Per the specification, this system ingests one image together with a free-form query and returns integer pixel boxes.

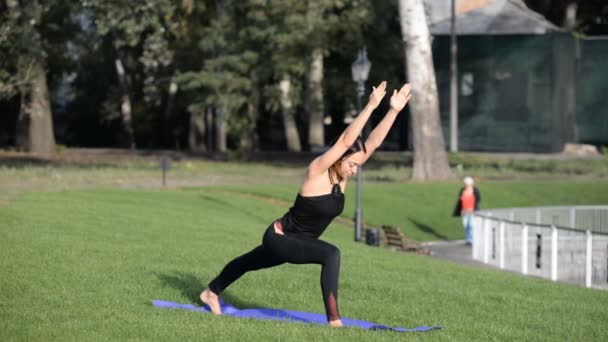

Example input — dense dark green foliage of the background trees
[0,0,607,148]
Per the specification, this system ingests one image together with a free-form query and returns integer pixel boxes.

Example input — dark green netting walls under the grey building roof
[433,34,608,152]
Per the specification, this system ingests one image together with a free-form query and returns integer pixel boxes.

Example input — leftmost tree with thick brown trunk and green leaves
[0,0,55,153]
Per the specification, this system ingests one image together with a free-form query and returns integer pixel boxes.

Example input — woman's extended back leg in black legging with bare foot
[200,245,285,315]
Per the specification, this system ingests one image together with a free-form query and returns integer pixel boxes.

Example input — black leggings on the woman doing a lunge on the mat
[209,224,340,321]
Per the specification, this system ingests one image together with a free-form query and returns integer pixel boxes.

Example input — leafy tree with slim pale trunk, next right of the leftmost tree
[82,0,183,148]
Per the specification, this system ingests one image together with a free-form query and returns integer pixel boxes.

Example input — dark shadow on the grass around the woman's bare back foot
[156,272,264,309]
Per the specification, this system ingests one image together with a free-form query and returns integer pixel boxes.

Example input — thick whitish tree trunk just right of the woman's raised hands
[399,0,452,180]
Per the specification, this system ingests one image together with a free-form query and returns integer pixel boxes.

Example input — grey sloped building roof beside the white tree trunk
[426,0,563,35]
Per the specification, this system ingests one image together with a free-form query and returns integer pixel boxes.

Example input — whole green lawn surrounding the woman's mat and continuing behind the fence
[0,187,608,341]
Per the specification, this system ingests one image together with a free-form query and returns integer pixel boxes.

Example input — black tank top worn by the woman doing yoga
[281,170,344,238]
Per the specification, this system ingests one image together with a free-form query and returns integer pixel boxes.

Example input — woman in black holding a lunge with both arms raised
[200,81,411,327]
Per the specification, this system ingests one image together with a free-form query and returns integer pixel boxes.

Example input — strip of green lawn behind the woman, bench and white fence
[221,180,608,241]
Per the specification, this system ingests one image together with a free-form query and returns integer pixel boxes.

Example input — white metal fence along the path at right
[473,206,608,289]
